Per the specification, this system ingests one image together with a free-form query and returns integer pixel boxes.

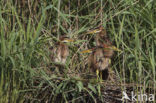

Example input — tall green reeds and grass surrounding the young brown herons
[0,0,156,103]
